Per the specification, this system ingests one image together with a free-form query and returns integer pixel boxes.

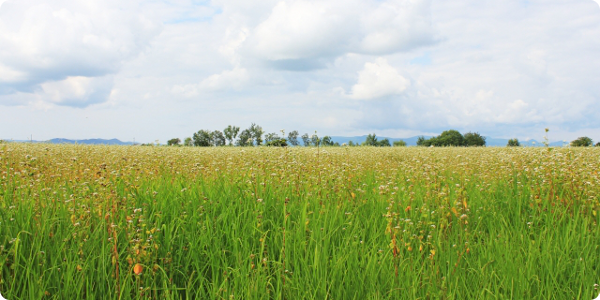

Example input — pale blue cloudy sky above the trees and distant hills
[0,0,600,143]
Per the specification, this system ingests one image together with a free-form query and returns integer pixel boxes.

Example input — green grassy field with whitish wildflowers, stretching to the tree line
[0,143,600,300]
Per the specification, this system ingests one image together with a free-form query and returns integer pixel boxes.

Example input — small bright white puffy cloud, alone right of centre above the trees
[350,57,410,99]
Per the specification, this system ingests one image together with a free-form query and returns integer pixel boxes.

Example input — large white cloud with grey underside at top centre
[241,0,436,71]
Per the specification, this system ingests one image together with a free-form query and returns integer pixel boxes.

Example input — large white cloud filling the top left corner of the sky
[0,0,160,105]
